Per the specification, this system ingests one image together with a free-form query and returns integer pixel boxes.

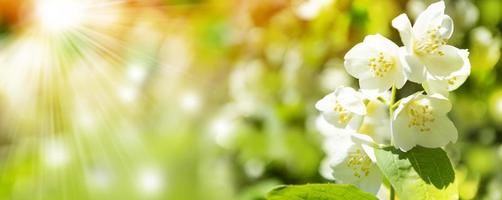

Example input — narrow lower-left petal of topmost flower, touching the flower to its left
[399,47,427,83]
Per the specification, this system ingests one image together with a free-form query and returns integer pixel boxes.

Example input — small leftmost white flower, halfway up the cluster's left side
[315,87,366,128]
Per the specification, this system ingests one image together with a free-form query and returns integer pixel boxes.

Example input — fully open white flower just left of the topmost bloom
[344,34,406,91]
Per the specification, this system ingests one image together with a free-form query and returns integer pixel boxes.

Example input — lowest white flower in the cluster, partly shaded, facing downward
[323,130,383,194]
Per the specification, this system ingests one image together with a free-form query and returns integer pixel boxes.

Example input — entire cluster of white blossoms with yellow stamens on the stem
[315,1,471,193]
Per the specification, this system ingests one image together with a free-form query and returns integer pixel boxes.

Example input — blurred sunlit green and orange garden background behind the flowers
[0,0,502,200]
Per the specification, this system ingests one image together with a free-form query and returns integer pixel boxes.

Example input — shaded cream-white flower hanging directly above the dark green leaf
[391,92,457,151]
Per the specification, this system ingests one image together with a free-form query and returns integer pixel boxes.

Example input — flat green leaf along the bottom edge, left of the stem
[267,184,377,200]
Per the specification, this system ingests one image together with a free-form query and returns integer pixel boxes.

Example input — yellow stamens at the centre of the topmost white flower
[413,26,448,56]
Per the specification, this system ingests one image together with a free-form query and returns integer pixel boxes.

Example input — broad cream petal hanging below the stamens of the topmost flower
[422,45,464,77]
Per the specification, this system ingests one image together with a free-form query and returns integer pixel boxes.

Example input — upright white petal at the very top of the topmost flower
[413,1,445,36]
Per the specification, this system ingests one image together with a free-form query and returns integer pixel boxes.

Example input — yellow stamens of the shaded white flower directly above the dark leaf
[407,102,434,132]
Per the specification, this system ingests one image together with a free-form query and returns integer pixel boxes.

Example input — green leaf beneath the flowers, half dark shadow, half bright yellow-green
[375,146,458,200]
